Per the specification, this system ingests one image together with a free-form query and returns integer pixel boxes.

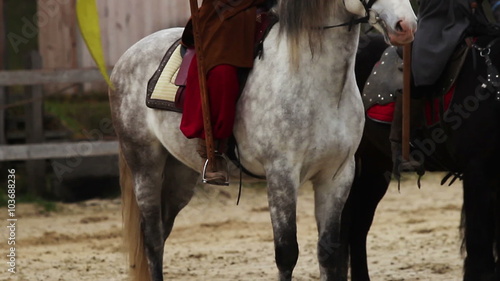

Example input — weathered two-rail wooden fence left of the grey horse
[0,55,118,194]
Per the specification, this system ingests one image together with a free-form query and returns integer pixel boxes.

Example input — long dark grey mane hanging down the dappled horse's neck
[277,0,338,62]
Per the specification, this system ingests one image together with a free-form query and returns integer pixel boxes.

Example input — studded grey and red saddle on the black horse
[362,40,470,126]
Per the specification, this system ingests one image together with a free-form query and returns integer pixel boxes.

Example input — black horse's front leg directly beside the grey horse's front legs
[344,153,391,281]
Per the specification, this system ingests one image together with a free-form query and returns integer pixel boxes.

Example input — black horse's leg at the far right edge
[463,161,497,281]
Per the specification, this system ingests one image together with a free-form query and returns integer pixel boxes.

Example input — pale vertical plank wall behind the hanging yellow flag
[37,0,190,71]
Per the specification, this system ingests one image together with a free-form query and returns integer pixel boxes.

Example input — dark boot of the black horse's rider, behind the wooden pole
[389,95,425,177]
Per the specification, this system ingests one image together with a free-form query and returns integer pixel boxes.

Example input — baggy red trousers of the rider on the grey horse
[180,56,240,139]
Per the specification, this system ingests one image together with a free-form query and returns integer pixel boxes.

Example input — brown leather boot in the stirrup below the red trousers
[196,139,229,185]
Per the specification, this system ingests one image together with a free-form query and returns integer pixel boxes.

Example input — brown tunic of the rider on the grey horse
[182,0,267,72]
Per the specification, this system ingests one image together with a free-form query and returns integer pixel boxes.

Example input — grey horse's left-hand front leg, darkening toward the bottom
[267,170,299,281]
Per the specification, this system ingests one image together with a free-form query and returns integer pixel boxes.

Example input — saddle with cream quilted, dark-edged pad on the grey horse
[146,11,278,113]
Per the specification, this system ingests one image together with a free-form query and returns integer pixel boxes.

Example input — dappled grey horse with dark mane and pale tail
[110,0,416,281]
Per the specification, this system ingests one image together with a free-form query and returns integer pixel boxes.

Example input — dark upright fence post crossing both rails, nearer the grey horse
[25,51,46,195]
